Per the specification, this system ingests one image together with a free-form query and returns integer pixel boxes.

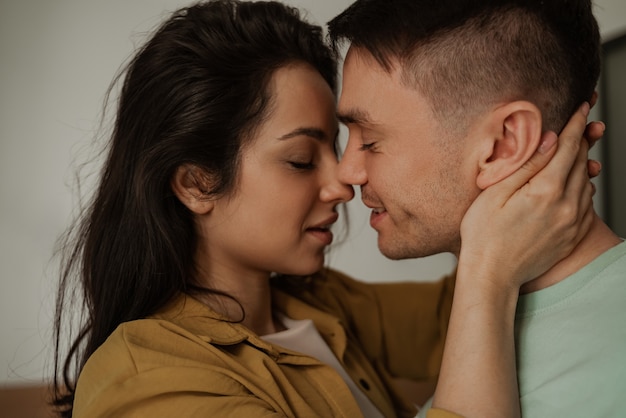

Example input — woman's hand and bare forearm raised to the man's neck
[433,104,604,417]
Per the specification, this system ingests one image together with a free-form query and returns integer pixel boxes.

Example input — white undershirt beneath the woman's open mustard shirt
[261,316,384,418]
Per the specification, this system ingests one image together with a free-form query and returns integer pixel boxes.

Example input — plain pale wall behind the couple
[0,0,626,385]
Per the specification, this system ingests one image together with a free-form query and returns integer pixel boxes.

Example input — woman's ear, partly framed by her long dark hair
[170,164,215,215]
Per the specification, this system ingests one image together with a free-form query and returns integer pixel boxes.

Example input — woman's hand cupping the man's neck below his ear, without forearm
[460,104,604,289]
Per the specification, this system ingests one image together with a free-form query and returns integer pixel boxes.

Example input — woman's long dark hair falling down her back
[53,0,336,417]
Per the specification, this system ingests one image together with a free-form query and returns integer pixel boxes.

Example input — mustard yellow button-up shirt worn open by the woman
[74,270,455,418]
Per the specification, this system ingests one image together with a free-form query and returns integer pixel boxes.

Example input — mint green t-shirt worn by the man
[515,242,626,418]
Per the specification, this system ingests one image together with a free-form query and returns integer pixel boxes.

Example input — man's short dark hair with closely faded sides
[328,0,600,132]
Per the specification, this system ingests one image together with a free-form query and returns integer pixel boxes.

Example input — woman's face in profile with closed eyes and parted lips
[199,64,354,277]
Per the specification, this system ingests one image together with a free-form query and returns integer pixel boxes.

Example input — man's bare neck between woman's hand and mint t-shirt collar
[520,215,621,294]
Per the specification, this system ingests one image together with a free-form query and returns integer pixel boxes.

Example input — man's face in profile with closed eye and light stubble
[338,47,479,259]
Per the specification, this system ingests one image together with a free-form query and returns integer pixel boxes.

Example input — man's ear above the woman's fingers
[476,101,542,190]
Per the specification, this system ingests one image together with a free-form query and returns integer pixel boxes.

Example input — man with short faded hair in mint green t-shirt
[329,0,626,417]
